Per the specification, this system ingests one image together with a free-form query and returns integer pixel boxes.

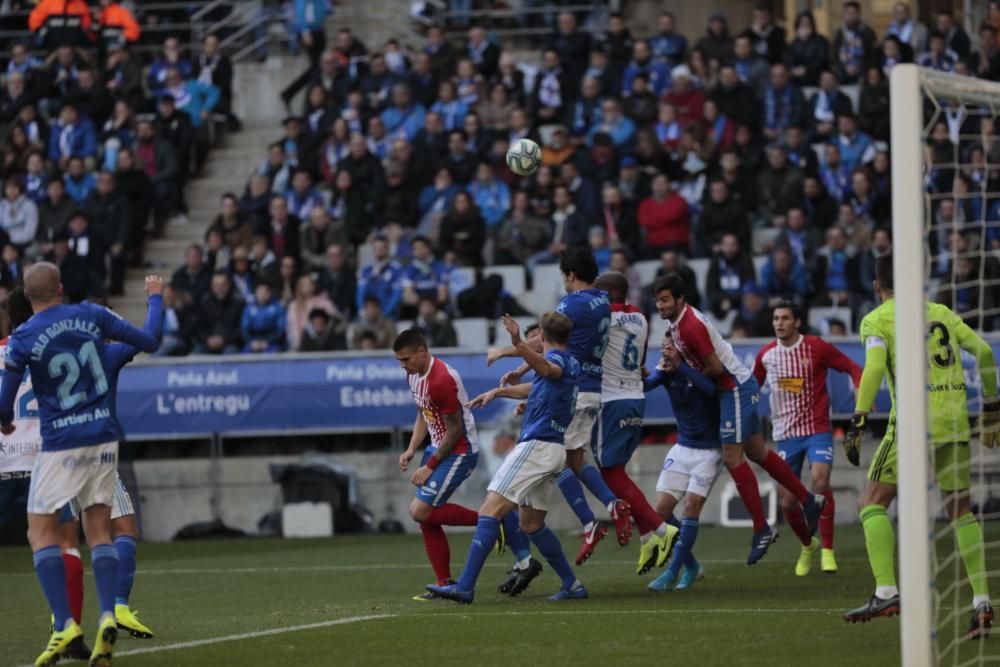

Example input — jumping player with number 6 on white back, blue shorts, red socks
[592,271,679,574]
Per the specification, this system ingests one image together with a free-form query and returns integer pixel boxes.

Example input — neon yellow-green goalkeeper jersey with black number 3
[857,299,996,444]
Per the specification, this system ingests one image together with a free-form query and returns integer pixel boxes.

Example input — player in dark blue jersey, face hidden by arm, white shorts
[643,336,722,591]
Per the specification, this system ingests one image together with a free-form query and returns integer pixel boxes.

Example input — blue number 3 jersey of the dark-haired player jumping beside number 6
[556,287,611,394]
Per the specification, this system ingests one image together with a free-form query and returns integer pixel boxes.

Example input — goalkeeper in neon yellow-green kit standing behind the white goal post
[844,256,1000,639]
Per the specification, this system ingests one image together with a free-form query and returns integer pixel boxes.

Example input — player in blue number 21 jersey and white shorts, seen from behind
[0,262,158,667]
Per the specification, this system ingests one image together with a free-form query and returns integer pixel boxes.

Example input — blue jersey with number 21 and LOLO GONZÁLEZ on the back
[0,296,160,451]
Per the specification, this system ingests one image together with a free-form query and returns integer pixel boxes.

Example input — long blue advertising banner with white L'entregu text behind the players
[118,341,1000,439]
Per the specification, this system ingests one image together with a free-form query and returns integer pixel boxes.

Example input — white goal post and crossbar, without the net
[889,65,1000,667]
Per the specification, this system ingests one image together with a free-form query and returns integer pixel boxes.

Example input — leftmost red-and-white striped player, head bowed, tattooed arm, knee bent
[392,329,479,600]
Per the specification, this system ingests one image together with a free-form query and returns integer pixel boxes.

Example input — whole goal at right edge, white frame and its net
[891,65,1000,666]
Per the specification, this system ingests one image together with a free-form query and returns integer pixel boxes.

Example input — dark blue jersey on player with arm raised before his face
[643,363,722,449]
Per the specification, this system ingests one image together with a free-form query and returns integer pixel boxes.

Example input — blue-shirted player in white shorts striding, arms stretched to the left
[427,313,587,604]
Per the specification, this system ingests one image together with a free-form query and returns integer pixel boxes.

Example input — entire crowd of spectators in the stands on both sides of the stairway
[0,0,1000,354]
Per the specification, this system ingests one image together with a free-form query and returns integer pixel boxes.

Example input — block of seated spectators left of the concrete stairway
[0,0,240,324]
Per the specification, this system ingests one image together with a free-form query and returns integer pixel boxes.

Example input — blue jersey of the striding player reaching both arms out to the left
[519,350,580,445]
